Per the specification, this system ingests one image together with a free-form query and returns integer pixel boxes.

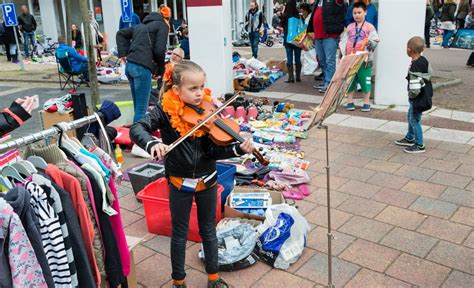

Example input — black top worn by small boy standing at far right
[406,56,433,112]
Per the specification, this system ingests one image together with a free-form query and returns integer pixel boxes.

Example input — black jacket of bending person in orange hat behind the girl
[116,13,169,75]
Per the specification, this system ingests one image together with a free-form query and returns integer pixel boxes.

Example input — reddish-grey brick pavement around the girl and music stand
[120,125,474,287]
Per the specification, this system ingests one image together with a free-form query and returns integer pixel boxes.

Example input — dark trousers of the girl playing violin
[169,185,219,280]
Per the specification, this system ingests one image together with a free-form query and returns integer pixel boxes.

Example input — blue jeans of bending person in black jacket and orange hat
[125,62,151,123]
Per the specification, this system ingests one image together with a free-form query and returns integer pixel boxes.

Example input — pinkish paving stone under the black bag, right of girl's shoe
[218,261,272,287]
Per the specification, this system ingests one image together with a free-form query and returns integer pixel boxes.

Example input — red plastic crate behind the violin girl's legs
[137,178,224,242]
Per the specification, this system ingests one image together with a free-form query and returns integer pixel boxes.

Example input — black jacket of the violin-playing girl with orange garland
[130,106,245,178]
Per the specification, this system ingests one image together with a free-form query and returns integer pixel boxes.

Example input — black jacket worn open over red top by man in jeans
[306,0,346,34]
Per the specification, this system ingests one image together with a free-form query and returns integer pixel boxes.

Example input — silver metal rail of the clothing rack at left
[0,113,98,153]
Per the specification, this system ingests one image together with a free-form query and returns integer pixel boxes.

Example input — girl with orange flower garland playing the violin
[130,60,253,288]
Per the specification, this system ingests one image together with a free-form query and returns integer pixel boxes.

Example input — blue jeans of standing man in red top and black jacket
[316,38,337,87]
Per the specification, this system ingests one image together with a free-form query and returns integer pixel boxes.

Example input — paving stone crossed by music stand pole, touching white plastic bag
[306,227,355,256]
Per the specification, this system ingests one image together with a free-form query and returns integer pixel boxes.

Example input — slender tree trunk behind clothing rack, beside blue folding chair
[79,0,100,110]
